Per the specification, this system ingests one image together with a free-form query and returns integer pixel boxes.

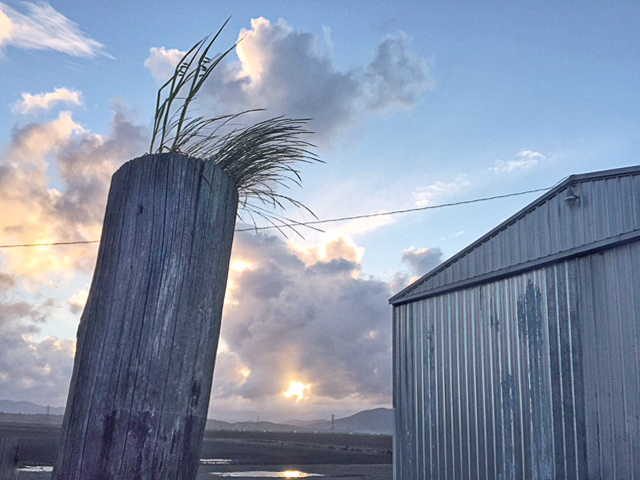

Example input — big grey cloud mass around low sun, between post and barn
[214,234,391,418]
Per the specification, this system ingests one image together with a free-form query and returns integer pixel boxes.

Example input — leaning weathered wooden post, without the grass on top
[52,153,238,480]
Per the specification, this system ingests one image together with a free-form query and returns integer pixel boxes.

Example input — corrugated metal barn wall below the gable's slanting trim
[394,240,640,480]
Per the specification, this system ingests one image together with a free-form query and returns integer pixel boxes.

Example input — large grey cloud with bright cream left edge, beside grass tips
[200,17,361,144]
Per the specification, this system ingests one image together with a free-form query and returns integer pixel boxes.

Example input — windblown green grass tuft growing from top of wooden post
[149,19,320,233]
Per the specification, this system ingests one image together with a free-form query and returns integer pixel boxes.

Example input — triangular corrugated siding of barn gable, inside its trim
[404,170,640,296]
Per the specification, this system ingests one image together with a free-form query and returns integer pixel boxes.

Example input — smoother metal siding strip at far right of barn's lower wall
[578,242,640,479]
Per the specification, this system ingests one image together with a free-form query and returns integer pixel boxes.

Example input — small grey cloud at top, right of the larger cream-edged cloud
[366,32,435,109]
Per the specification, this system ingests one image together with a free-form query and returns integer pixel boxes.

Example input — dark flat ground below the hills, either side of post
[0,424,392,480]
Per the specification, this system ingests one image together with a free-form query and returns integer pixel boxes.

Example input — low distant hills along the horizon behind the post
[0,400,393,435]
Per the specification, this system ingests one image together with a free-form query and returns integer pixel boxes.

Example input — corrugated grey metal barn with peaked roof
[390,167,640,480]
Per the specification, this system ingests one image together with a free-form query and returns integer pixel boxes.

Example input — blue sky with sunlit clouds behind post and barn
[0,0,640,421]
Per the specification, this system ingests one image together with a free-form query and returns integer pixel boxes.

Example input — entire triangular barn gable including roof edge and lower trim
[389,166,640,305]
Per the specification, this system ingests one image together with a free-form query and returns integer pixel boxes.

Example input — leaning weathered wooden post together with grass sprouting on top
[53,25,317,480]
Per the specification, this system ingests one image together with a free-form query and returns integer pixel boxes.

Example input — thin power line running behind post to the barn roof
[0,187,553,248]
